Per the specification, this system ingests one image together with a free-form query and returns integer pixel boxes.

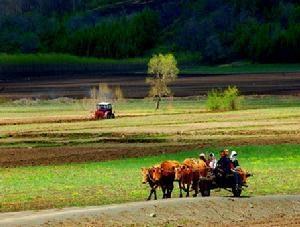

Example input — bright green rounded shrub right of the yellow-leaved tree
[206,86,242,111]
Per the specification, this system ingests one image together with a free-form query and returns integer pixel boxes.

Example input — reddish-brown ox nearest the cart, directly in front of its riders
[175,158,207,197]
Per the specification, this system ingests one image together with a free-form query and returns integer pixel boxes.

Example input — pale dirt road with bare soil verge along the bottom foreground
[0,195,300,227]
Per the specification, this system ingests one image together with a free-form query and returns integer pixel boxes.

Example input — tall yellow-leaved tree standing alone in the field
[146,54,179,109]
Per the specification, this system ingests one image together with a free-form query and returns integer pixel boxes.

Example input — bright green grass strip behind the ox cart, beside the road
[0,145,300,212]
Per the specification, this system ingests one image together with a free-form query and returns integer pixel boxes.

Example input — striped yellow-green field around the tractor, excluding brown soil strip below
[0,96,300,148]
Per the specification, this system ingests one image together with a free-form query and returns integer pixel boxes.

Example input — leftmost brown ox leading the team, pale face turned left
[142,166,161,200]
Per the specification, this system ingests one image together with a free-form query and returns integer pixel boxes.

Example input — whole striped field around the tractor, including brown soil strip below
[0,96,300,166]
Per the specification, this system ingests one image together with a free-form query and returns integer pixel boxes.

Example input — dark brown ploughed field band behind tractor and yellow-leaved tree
[0,73,300,98]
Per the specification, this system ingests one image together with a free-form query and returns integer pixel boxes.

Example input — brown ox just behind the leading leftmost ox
[160,160,180,198]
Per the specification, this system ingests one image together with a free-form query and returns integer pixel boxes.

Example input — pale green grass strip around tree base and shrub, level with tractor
[0,95,300,118]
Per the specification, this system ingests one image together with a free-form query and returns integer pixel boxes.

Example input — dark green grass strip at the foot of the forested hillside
[0,54,300,74]
